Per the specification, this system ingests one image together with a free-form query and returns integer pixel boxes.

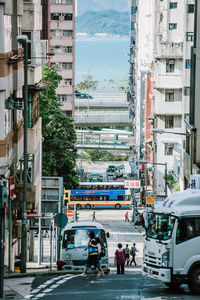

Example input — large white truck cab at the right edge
[142,189,200,294]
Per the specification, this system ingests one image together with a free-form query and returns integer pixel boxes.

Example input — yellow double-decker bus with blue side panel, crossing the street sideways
[63,182,133,209]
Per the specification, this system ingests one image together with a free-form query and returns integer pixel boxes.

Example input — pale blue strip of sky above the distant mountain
[77,0,130,16]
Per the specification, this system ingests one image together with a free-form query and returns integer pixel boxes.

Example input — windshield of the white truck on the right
[146,214,175,240]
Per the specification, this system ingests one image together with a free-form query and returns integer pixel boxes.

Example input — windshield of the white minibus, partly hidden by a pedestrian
[63,229,107,249]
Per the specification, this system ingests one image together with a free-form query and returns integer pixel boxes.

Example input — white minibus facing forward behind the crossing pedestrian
[62,221,109,273]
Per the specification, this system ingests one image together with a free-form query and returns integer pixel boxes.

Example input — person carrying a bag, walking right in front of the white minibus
[83,231,103,276]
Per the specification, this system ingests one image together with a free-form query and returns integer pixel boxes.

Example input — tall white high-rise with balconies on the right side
[132,0,194,194]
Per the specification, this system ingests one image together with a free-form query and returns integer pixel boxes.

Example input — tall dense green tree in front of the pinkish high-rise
[40,66,78,188]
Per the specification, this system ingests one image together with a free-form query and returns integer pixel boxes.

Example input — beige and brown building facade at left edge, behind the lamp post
[0,0,47,270]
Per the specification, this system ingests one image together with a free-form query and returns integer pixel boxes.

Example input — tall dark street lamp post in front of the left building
[17,35,28,273]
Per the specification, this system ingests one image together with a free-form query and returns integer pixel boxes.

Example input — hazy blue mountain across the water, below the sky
[76,10,130,35]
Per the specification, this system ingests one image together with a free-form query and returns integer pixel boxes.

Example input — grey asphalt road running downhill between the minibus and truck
[25,210,200,300]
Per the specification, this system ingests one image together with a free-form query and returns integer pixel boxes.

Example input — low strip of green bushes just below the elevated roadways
[81,149,128,161]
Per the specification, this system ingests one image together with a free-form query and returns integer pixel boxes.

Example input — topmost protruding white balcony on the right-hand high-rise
[155,43,183,59]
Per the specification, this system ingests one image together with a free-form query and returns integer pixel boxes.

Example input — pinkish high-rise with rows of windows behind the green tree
[49,0,75,117]
